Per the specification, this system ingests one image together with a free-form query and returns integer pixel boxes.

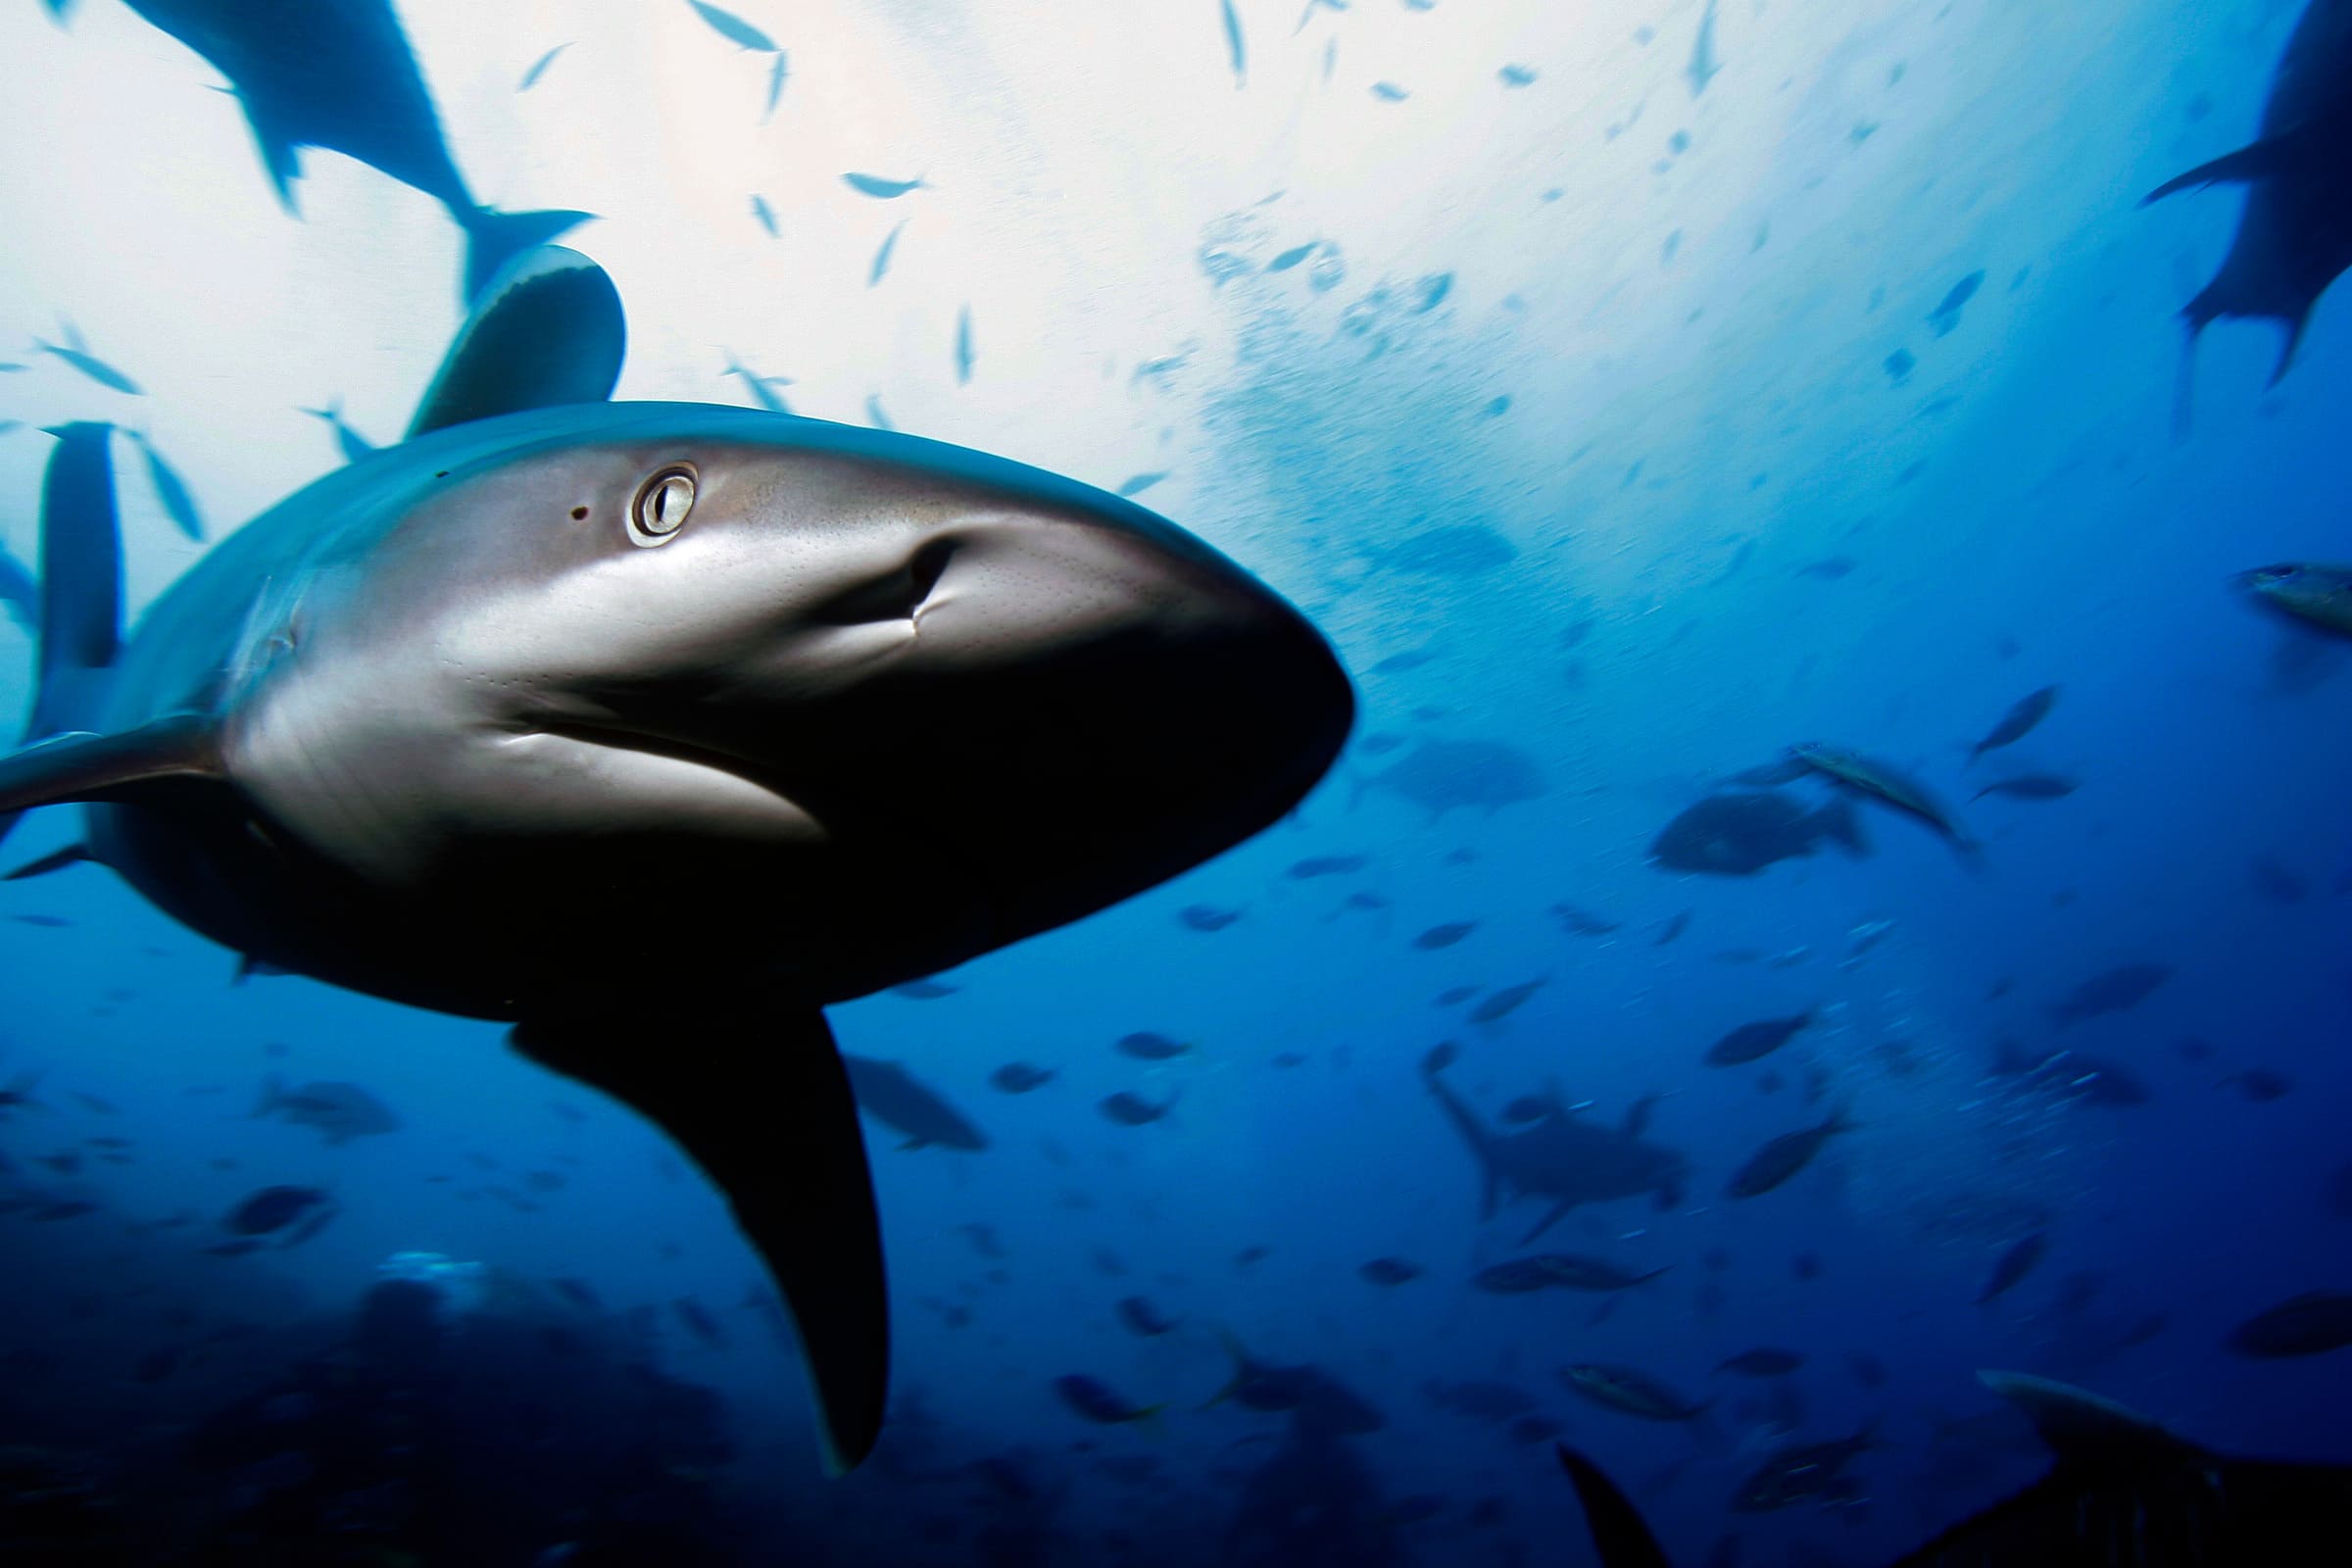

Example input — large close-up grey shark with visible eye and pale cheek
[0,247,1352,1464]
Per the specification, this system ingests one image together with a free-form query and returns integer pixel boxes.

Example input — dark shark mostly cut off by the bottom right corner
[1559,1373,2352,1568]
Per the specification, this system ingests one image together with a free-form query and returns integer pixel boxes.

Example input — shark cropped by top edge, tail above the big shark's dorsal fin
[49,0,588,299]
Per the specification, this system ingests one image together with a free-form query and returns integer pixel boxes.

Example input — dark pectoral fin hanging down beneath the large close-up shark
[513,999,889,1472]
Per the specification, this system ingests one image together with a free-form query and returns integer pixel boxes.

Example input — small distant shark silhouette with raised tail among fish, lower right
[1423,1069,1691,1246]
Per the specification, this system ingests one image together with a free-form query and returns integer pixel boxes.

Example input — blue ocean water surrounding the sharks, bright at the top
[0,0,2352,1568]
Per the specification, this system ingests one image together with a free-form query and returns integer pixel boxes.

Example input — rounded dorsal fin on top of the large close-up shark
[410,244,628,437]
